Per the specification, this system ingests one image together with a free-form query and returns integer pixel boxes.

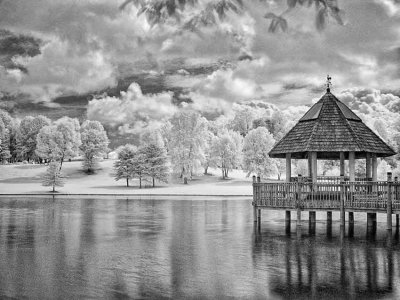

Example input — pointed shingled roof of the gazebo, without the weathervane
[269,89,396,159]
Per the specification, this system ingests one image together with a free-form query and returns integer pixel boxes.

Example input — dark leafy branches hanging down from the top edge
[120,0,344,32]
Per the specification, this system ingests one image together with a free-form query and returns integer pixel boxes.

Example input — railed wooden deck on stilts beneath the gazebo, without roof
[253,173,400,230]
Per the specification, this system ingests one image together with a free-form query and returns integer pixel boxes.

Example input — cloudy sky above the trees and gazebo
[0,0,400,138]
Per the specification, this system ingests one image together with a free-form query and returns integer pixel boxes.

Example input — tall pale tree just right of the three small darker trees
[167,110,206,183]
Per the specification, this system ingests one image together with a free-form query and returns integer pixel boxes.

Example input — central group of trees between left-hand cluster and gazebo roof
[113,106,304,186]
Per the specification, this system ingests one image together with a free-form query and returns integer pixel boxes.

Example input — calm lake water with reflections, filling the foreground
[0,198,400,299]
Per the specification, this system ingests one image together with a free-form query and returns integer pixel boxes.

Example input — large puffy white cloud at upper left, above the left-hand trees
[16,37,116,101]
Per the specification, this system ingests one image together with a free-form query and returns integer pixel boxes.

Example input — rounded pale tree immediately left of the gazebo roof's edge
[243,127,276,177]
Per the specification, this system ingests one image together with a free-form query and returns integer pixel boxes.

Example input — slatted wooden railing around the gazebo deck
[253,181,400,211]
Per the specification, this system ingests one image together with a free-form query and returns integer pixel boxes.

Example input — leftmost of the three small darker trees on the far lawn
[114,144,137,187]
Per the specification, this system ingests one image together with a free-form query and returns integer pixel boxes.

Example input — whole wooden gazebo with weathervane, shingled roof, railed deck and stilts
[253,77,400,230]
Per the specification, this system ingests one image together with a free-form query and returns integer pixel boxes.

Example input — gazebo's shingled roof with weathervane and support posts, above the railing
[269,77,396,182]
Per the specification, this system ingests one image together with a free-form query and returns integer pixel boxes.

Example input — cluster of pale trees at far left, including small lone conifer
[0,110,109,191]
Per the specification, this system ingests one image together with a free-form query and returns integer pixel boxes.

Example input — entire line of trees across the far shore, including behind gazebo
[0,105,400,191]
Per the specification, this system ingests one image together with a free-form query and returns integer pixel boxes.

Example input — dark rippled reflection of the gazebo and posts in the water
[253,228,400,299]
